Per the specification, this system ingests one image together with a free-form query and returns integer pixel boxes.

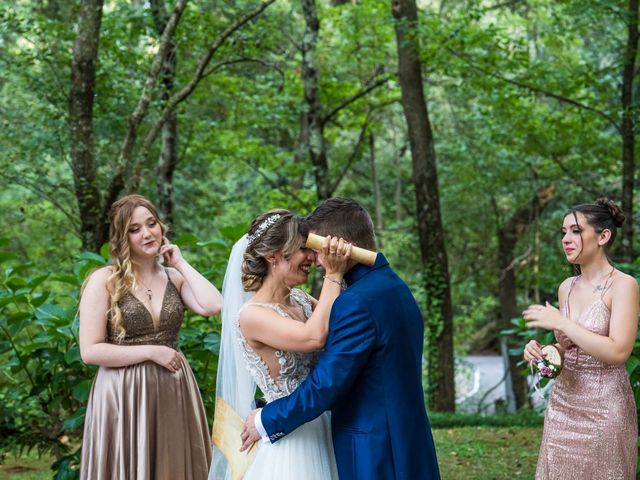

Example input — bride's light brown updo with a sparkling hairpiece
[242,208,304,292]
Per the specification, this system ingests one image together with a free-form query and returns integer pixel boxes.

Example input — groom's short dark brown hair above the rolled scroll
[301,197,376,250]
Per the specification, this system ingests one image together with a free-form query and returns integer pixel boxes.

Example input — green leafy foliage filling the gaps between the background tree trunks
[0,0,640,462]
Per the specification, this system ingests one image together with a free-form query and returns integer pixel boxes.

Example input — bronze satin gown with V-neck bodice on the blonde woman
[80,273,211,480]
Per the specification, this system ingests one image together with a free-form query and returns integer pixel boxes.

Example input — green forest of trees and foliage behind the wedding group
[0,0,640,478]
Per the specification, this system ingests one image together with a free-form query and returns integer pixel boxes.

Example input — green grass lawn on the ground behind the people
[0,427,542,480]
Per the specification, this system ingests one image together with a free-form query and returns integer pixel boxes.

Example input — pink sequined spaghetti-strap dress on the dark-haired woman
[536,277,638,480]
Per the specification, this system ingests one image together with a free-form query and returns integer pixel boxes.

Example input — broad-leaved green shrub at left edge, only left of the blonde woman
[0,241,105,478]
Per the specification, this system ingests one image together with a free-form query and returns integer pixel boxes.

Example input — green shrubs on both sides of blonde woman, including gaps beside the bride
[0,228,232,479]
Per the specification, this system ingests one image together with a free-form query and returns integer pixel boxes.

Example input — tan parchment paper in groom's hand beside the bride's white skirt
[211,397,258,480]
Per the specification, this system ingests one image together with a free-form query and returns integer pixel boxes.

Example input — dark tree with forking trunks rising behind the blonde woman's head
[70,0,275,250]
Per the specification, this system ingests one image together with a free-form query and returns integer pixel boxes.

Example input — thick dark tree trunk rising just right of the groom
[392,0,455,412]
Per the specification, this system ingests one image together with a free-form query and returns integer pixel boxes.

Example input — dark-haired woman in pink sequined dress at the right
[523,198,639,480]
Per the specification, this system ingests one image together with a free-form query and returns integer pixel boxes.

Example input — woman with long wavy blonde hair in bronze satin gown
[80,195,222,480]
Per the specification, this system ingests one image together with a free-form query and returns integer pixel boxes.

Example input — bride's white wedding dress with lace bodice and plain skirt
[237,289,338,480]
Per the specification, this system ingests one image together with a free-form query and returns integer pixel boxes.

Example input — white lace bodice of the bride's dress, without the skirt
[236,289,319,402]
